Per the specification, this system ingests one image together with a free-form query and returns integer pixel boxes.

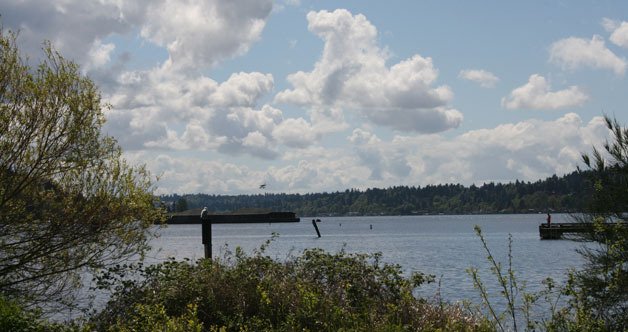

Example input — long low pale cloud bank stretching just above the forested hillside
[140,113,609,194]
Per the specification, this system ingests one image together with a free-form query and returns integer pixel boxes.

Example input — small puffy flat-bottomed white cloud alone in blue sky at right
[502,74,589,110]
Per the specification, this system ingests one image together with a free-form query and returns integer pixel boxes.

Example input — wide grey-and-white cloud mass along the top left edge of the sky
[2,0,273,69]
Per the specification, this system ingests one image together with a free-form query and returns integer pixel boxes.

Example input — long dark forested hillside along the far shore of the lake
[161,171,592,216]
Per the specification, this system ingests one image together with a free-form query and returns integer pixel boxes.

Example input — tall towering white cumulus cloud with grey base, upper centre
[275,9,462,132]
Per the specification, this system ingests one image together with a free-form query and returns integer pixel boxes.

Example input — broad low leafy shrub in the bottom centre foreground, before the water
[90,243,490,331]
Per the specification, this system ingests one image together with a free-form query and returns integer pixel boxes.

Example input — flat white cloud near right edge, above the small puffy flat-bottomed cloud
[550,36,626,75]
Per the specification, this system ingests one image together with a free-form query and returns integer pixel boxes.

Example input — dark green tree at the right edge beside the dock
[570,116,628,331]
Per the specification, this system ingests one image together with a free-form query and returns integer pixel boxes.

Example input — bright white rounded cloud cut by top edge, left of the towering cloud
[141,0,272,69]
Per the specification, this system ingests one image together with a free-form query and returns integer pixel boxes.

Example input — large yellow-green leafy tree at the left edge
[0,29,162,303]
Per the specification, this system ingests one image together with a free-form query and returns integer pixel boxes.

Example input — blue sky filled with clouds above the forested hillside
[0,0,628,195]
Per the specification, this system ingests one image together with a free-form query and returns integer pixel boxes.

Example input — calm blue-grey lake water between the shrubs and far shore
[150,214,583,303]
